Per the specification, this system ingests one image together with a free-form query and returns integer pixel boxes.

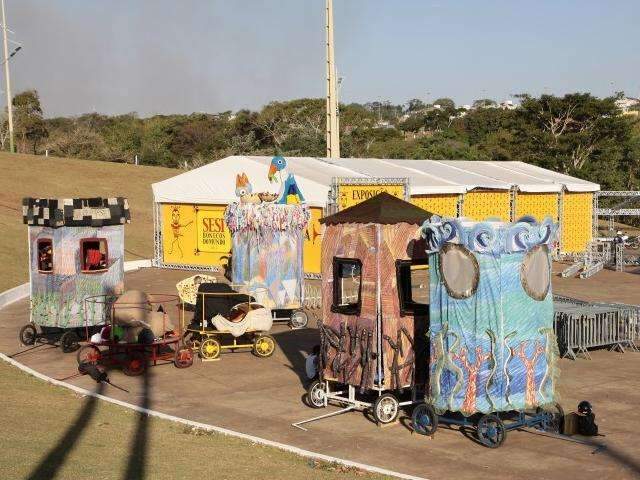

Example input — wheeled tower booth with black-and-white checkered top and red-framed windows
[20,197,131,352]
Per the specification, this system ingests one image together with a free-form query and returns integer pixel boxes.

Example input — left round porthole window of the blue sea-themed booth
[440,243,480,299]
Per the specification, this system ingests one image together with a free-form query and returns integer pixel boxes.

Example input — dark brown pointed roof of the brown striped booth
[320,192,431,225]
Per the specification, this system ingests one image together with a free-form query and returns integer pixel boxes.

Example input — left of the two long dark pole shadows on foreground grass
[27,383,105,480]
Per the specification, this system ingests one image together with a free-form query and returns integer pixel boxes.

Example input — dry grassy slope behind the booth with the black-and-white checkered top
[0,153,175,291]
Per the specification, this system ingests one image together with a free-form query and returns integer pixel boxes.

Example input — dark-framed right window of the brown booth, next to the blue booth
[396,259,429,315]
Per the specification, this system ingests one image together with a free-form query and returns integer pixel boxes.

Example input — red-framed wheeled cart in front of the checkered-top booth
[77,294,193,376]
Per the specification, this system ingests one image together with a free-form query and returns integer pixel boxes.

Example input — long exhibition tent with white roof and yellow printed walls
[153,156,600,276]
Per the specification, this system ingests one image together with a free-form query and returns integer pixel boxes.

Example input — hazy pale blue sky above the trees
[3,0,640,116]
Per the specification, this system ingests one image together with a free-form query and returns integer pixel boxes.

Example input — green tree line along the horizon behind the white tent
[6,90,640,190]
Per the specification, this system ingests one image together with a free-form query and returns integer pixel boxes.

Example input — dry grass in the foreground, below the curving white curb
[0,361,385,480]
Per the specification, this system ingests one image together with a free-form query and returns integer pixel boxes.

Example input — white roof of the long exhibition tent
[153,155,600,207]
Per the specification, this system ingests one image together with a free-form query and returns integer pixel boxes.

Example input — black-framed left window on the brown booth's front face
[331,257,362,315]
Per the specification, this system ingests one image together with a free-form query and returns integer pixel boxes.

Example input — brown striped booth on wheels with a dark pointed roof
[294,193,431,428]
